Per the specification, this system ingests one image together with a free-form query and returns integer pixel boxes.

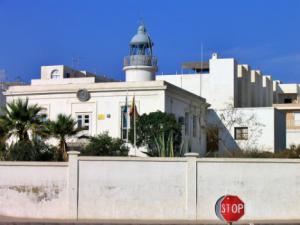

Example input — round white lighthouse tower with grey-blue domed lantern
[123,25,157,81]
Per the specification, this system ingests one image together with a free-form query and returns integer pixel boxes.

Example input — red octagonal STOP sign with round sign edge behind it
[215,195,245,222]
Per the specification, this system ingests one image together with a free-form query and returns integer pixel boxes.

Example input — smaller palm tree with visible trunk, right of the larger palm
[48,114,82,161]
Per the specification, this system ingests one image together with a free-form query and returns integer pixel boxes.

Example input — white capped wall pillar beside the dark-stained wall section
[68,151,80,220]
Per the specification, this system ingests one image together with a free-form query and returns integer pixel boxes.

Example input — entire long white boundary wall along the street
[0,152,300,221]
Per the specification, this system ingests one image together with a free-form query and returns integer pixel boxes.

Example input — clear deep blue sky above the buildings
[0,0,300,83]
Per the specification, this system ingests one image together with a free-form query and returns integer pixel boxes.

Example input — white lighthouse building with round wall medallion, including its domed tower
[5,26,208,155]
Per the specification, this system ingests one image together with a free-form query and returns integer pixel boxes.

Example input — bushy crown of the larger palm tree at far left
[0,99,46,141]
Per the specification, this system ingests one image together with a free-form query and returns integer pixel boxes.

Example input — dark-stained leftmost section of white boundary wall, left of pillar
[0,162,69,219]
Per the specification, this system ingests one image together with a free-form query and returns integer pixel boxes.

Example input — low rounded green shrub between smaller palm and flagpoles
[81,133,129,156]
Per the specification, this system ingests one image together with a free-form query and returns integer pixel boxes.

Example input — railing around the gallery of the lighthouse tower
[124,55,157,67]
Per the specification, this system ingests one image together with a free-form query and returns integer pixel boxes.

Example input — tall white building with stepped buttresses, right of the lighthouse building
[156,54,286,152]
